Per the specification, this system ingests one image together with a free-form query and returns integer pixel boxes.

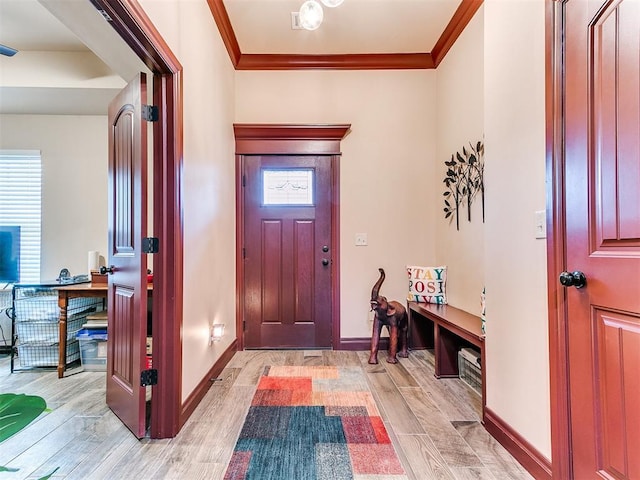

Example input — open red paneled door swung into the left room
[107,73,147,438]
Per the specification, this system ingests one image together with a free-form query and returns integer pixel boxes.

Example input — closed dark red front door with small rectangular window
[243,155,332,348]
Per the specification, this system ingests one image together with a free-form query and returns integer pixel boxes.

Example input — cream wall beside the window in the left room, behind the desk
[0,115,108,281]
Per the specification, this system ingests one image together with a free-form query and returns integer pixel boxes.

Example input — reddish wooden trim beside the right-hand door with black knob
[545,0,573,479]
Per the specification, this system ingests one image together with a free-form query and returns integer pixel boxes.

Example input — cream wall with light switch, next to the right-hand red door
[484,0,551,458]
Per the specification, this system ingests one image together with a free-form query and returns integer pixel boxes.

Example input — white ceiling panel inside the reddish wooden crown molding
[224,0,460,54]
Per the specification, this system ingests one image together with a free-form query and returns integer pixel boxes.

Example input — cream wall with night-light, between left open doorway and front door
[141,0,236,401]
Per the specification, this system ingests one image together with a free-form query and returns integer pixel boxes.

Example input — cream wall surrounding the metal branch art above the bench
[433,7,485,315]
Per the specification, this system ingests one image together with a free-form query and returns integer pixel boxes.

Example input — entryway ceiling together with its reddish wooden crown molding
[207,0,482,70]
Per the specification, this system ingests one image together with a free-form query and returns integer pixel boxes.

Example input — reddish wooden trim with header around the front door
[233,123,351,350]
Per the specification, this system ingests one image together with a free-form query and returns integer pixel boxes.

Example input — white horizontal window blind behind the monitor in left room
[0,150,42,287]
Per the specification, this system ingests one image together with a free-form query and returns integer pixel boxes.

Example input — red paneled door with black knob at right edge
[564,0,640,479]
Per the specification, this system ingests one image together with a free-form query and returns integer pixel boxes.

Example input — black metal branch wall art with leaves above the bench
[443,142,484,230]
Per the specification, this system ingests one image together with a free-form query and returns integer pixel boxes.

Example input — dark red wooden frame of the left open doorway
[90,0,186,438]
